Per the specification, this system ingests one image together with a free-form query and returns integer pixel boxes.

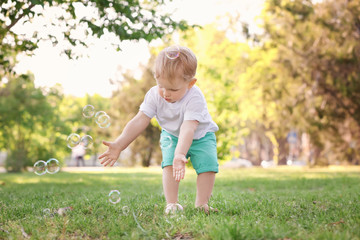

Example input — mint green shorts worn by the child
[160,130,219,175]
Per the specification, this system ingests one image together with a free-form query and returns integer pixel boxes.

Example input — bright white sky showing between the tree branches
[14,0,264,97]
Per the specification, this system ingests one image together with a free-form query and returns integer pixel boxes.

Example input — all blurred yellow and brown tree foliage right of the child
[167,0,360,164]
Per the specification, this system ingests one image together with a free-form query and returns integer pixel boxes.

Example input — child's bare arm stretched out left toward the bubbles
[99,111,151,166]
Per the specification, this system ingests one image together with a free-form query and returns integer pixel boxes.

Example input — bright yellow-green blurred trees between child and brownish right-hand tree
[184,24,286,165]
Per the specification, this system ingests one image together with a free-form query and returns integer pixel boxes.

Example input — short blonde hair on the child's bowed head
[154,46,197,82]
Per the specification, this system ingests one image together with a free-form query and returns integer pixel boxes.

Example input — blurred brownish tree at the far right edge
[253,0,360,164]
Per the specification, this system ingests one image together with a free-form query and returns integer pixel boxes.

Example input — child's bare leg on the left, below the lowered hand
[163,166,179,204]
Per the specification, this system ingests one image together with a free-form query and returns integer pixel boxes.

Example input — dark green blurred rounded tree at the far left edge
[0,74,66,172]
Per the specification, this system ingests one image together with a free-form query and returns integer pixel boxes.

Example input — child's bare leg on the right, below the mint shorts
[195,172,215,207]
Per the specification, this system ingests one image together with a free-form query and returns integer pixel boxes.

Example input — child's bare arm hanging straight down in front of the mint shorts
[173,120,199,182]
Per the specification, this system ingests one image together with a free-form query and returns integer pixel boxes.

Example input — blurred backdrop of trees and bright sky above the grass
[0,0,360,172]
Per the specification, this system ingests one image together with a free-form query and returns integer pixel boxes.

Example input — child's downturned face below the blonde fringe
[156,78,196,103]
